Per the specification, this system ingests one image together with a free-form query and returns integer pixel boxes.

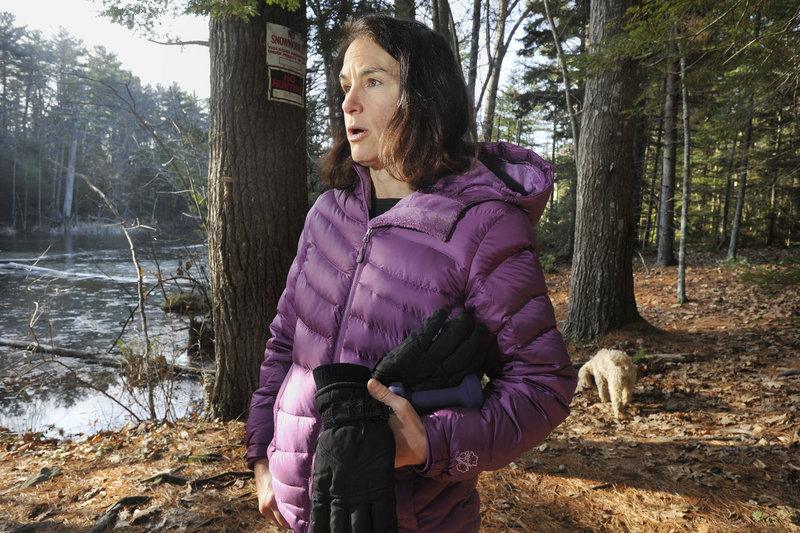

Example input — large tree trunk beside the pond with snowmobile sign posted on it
[207,2,308,419]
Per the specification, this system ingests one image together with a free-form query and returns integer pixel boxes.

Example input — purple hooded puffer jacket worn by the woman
[247,139,576,533]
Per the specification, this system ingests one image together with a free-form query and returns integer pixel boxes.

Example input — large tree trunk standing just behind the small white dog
[564,0,639,340]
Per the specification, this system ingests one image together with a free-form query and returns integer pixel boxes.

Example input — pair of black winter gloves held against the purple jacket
[311,309,484,533]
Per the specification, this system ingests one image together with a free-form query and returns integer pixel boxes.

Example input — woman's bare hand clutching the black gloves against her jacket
[367,379,428,468]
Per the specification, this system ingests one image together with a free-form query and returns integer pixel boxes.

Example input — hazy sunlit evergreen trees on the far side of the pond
[0,13,208,230]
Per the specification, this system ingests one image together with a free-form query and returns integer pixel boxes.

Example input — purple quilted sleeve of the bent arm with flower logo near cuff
[419,203,576,480]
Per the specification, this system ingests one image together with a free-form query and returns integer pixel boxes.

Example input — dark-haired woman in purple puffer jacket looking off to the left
[247,16,576,532]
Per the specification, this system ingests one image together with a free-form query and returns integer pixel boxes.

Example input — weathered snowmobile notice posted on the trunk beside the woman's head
[267,22,306,107]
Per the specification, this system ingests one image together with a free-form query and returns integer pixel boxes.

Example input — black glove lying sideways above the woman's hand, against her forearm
[372,309,486,392]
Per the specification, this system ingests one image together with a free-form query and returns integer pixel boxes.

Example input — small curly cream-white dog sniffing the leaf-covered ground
[578,348,636,418]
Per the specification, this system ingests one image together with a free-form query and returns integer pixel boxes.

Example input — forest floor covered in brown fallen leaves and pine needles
[0,250,800,533]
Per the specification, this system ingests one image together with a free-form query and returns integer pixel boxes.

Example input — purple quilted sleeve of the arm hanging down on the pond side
[247,218,308,468]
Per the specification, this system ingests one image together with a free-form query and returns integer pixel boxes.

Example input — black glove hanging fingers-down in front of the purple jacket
[311,363,397,533]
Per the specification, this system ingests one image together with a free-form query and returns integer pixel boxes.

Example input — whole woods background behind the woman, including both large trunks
[0,0,800,418]
